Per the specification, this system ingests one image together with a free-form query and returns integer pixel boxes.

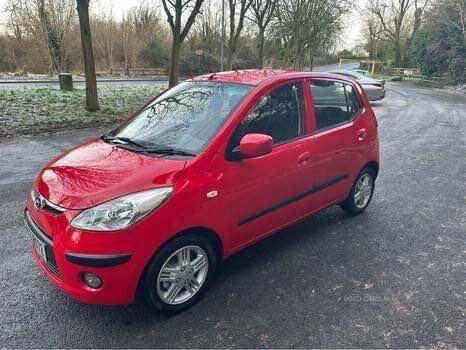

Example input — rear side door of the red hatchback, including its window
[308,79,366,208]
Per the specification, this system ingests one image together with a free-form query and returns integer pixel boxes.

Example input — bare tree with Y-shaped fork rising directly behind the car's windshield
[162,0,204,87]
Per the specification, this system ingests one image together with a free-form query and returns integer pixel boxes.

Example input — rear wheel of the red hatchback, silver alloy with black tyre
[340,168,375,215]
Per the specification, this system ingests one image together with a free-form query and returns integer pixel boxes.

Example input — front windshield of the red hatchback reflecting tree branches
[111,82,252,154]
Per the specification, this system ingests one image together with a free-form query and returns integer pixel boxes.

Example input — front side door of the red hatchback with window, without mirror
[223,81,312,249]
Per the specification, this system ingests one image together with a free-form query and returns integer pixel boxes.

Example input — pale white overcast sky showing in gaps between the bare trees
[0,0,367,48]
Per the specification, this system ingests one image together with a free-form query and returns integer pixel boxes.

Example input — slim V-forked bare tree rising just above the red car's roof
[227,0,251,70]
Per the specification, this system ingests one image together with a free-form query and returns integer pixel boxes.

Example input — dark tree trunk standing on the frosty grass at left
[76,0,99,111]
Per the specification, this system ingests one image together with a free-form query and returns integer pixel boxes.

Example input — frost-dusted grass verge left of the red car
[0,85,162,138]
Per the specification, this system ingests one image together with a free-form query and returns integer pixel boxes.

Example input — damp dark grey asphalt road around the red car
[0,84,466,348]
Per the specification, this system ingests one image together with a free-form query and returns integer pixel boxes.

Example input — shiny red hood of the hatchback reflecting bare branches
[35,139,186,209]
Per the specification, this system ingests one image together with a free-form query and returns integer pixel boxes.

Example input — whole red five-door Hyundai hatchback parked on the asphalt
[25,70,379,311]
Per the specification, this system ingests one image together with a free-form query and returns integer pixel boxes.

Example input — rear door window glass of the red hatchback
[311,80,361,130]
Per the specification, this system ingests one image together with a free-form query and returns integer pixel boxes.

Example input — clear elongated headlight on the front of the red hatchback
[71,187,173,231]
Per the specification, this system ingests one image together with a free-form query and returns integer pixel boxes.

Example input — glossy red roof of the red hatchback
[192,69,354,86]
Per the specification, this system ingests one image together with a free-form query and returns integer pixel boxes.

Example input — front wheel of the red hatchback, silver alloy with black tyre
[143,234,218,313]
